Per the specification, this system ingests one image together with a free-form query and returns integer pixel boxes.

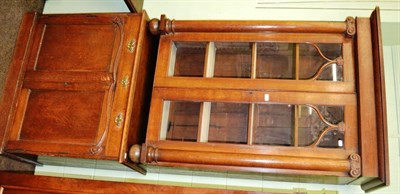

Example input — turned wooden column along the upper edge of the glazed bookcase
[149,15,356,37]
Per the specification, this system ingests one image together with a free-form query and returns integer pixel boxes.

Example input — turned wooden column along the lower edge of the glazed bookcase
[141,144,361,177]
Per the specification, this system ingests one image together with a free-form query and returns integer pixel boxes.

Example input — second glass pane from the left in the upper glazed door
[214,42,251,78]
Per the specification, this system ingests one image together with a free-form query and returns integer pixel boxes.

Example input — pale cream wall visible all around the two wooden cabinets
[36,0,400,194]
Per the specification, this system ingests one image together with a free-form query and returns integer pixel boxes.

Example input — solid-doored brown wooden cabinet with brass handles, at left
[0,12,156,171]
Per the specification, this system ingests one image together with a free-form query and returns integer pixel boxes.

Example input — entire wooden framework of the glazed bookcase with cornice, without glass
[133,8,388,190]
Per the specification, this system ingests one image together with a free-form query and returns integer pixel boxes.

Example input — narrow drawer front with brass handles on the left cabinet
[105,14,142,158]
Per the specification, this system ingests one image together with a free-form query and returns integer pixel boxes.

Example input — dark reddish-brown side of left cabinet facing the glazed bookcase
[119,12,158,162]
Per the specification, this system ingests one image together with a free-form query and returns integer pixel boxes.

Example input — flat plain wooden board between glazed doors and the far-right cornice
[356,18,378,177]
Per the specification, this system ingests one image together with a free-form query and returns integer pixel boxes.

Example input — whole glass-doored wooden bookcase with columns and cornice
[131,7,388,190]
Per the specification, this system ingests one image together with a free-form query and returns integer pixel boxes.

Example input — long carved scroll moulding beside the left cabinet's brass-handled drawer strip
[89,17,124,155]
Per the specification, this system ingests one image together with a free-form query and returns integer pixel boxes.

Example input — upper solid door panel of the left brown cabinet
[28,14,126,72]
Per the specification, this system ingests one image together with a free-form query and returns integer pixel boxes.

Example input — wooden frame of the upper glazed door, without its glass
[154,33,355,93]
